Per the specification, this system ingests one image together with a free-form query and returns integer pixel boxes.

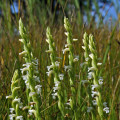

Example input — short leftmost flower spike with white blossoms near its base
[6,70,23,120]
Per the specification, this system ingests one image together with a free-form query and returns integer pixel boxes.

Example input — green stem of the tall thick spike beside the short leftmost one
[19,19,41,120]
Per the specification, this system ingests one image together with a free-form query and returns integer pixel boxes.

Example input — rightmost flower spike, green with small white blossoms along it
[88,34,109,120]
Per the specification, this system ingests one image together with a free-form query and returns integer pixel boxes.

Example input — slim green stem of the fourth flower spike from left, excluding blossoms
[64,18,78,120]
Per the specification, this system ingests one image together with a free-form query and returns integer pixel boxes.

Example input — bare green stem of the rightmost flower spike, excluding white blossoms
[89,35,103,120]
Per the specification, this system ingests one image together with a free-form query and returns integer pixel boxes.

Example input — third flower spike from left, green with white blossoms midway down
[46,27,65,119]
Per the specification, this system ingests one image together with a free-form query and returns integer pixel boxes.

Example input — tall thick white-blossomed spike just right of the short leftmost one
[19,19,42,120]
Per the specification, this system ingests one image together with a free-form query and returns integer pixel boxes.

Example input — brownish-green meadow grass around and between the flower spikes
[0,0,120,120]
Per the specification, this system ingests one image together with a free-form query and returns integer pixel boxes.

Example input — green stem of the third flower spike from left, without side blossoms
[46,28,65,119]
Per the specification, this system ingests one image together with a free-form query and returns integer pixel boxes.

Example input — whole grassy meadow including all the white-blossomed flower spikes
[0,0,120,120]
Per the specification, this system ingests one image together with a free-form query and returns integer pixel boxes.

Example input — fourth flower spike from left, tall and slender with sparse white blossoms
[63,18,79,119]
